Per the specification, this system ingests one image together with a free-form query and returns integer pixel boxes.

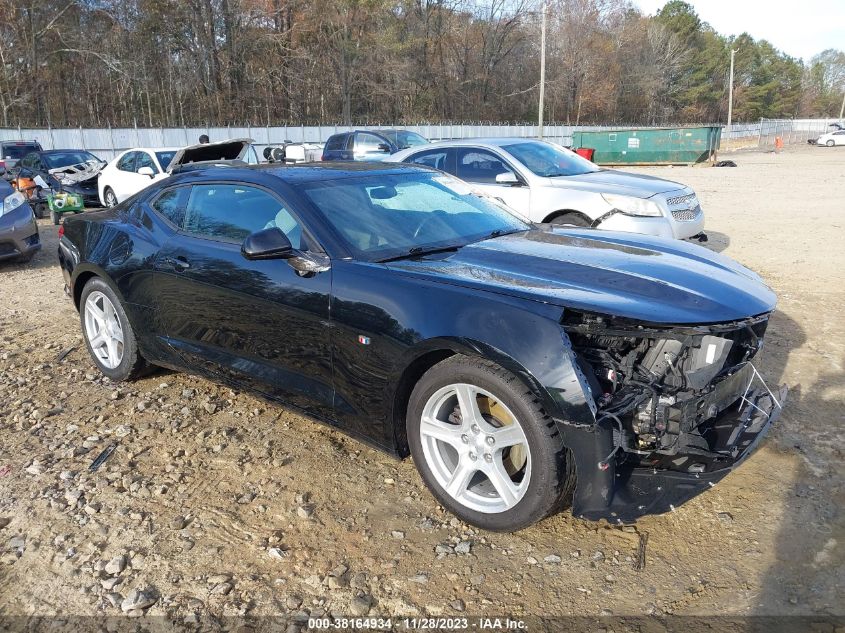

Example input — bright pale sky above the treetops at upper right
[633,0,845,61]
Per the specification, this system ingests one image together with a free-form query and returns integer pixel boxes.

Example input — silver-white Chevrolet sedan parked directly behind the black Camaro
[385,138,707,241]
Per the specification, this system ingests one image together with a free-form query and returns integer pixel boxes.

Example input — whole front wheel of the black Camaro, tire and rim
[406,355,575,532]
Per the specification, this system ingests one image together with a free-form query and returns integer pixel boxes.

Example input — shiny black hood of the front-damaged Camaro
[387,228,776,324]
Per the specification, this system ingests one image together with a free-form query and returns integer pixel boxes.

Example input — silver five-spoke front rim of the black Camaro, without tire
[420,383,531,513]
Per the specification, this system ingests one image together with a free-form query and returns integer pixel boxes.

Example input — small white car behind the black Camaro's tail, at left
[97,147,179,207]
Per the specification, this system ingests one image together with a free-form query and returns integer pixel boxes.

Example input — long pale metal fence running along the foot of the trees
[0,119,836,160]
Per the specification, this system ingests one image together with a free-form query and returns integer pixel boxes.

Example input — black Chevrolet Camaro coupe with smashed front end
[59,163,786,530]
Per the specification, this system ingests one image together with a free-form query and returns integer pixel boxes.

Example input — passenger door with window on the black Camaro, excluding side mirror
[150,182,334,417]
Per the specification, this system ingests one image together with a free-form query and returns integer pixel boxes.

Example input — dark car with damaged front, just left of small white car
[17,149,106,210]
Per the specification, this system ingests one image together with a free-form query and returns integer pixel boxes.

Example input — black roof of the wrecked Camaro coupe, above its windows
[169,162,435,183]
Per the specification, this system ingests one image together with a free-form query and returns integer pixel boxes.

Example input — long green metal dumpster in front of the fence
[572,126,722,165]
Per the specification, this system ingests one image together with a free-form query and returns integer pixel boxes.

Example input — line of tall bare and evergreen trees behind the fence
[0,0,845,127]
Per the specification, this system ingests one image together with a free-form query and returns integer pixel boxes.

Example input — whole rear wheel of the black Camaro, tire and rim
[79,277,146,382]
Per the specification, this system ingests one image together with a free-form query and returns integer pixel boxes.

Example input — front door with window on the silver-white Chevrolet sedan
[454,147,531,217]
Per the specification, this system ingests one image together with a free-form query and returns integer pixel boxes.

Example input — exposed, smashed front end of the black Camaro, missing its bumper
[561,311,787,523]
